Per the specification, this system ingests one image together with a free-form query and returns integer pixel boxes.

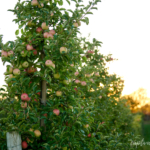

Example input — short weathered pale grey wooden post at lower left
[6,131,22,150]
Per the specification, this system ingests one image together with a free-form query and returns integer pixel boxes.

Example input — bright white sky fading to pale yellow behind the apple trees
[0,0,150,97]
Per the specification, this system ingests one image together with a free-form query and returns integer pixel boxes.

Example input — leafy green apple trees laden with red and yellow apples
[0,0,142,150]
